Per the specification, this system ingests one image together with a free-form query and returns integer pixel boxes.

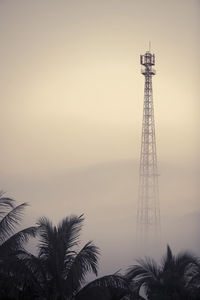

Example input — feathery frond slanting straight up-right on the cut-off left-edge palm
[0,203,28,242]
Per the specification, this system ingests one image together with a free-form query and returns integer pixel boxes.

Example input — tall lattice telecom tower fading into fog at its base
[137,51,160,246]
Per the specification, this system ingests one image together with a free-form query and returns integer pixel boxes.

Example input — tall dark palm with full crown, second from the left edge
[20,215,99,300]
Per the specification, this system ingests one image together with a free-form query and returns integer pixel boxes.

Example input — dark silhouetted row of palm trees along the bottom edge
[0,193,200,300]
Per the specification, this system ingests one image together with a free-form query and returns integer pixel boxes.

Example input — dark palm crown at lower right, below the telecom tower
[126,246,197,300]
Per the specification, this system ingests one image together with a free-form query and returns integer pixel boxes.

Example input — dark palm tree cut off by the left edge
[0,192,37,298]
